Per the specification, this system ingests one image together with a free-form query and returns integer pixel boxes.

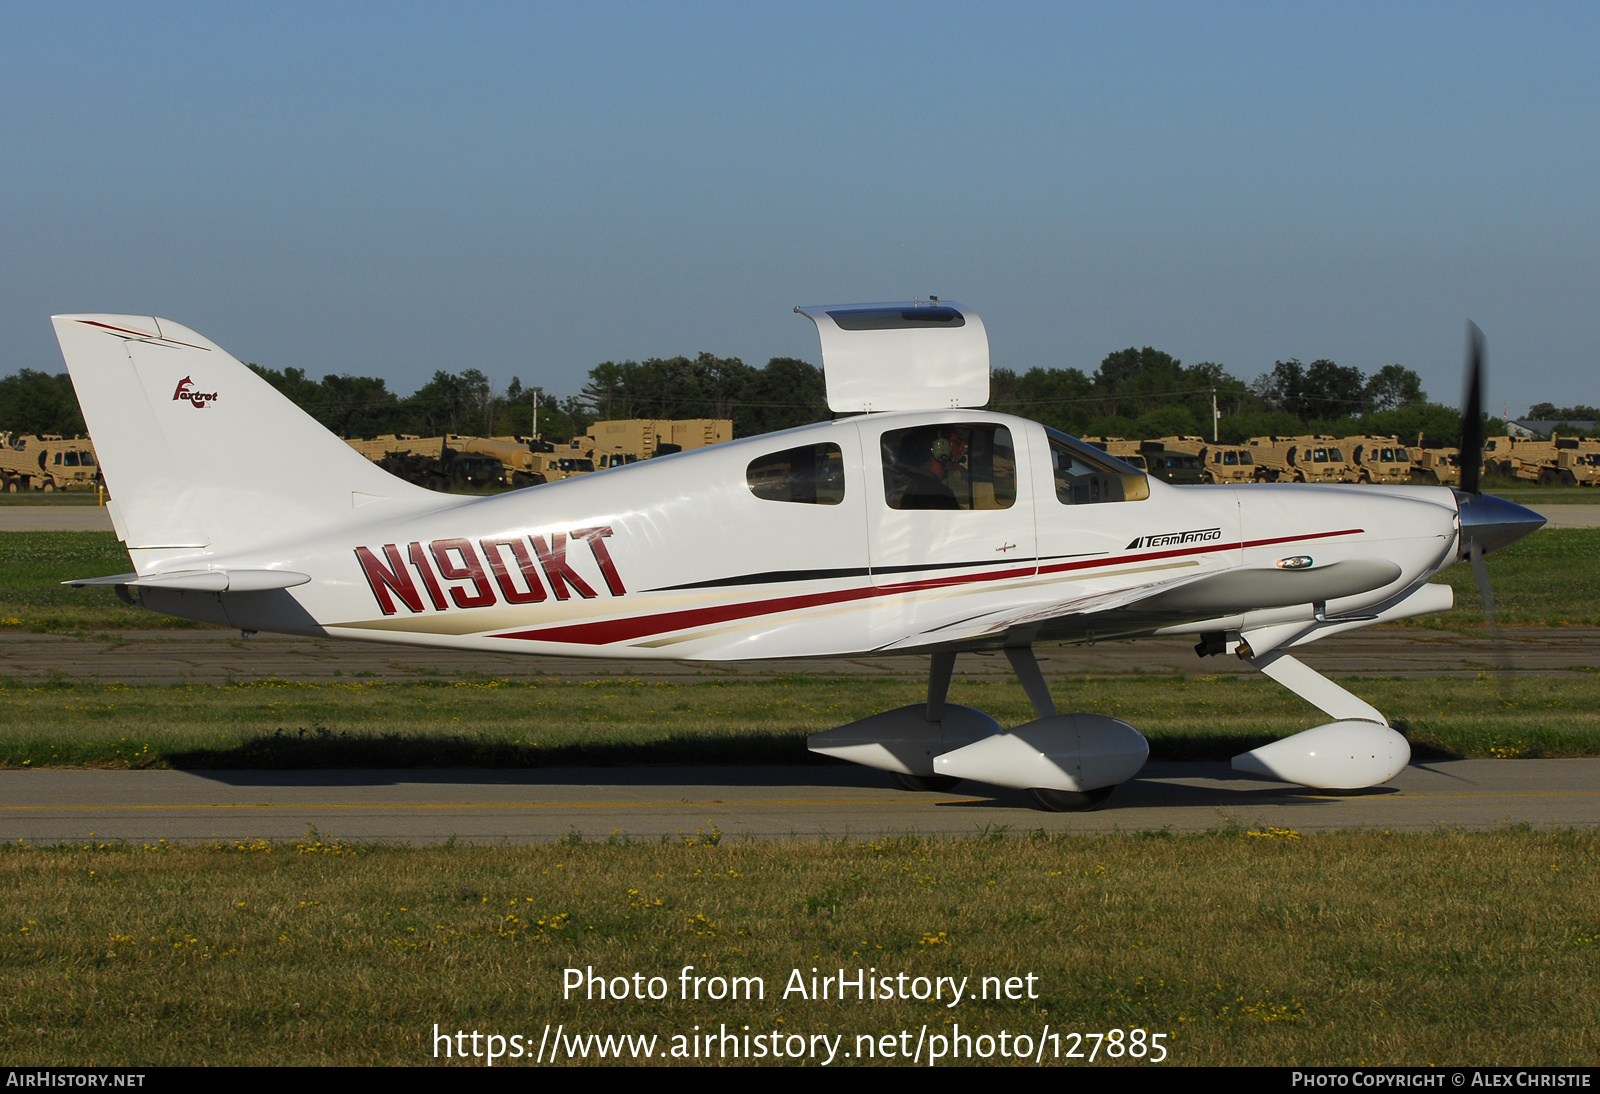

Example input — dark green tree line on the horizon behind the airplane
[0,345,1516,445]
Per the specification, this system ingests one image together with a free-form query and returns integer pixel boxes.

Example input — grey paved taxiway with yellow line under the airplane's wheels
[0,760,1600,844]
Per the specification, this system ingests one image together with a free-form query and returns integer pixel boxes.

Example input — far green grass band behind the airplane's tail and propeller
[0,527,1600,633]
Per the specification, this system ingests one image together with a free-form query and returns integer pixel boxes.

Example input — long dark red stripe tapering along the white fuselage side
[494,528,1363,646]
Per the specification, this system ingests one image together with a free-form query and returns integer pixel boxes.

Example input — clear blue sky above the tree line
[0,3,1600,414]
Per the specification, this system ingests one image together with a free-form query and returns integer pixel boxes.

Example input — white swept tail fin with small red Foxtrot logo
[53,315,438,552]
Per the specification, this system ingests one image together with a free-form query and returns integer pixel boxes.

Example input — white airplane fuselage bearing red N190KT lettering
[133,409,1458,661]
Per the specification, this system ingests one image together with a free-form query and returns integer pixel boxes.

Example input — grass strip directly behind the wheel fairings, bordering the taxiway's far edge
[0,673,1600,768]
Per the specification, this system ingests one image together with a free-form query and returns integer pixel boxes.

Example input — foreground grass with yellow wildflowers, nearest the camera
[0,828,1600,1067]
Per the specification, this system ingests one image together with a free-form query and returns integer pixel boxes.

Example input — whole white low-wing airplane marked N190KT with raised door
[54,301,1544,809]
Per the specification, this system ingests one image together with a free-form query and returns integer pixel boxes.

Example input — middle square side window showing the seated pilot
[882,422,1016,510]
